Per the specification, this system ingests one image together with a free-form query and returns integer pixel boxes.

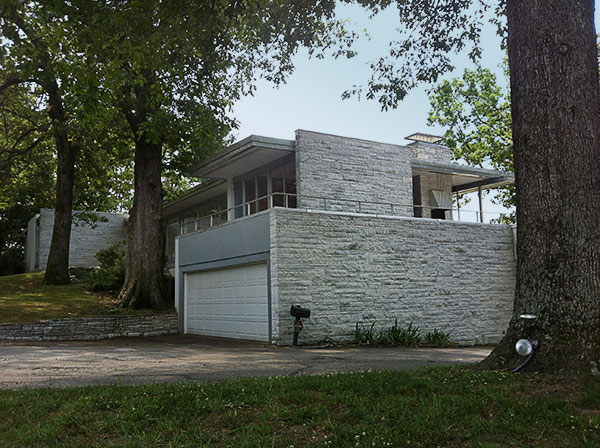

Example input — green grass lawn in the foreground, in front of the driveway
[0,367,600,448]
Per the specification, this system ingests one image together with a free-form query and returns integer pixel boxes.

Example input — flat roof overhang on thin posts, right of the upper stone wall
[411,159,515,193]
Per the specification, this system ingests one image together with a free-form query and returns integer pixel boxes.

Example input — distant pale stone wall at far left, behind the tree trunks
[27,208,128,271]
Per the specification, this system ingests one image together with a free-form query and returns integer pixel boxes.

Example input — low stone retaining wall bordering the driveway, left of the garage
[0,312,177,341]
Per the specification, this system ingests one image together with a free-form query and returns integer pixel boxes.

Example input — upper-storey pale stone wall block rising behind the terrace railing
[296,130,413,216]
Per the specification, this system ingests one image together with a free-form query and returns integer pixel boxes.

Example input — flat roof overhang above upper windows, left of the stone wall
[190,135,296,179]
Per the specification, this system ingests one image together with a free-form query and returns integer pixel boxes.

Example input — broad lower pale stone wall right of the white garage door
[271,209,516,345]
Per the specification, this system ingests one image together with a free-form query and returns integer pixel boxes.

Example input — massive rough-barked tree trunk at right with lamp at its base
[482,0,600,374]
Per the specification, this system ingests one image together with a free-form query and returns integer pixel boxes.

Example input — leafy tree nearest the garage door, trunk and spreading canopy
[57,0,354,308]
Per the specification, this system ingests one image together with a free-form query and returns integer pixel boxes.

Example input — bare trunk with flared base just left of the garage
[119,138,166,309]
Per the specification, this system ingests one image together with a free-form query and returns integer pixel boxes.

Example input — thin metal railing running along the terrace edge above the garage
[180,193,510,235]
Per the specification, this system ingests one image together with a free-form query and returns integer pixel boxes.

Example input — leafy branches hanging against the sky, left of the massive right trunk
[343,0,504,110]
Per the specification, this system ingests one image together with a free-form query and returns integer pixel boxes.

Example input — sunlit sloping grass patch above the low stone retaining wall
[0,272,149,323]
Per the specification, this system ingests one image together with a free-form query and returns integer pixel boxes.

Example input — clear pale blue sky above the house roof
[233,5,599,220]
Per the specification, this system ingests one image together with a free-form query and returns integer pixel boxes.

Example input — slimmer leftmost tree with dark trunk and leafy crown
[0,0,86,284]
